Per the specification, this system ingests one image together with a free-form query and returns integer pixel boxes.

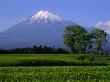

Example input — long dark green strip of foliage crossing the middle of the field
[0,59,108,67]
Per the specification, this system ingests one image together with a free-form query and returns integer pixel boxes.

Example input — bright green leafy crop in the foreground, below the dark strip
[0,66,110,82]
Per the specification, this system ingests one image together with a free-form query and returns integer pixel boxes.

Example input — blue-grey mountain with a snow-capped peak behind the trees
[0,10,74,49]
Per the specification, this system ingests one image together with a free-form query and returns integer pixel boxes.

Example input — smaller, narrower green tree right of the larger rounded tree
[91,28,107,54]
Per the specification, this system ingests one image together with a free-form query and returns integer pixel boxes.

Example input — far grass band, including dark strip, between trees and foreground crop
[0,54,110,67]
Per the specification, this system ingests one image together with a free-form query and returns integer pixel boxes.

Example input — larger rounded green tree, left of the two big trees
[63,25,90,53]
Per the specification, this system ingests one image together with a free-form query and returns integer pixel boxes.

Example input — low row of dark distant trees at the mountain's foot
[0,45,68,54]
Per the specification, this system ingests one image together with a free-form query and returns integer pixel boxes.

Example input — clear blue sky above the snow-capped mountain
[0,0,110,31]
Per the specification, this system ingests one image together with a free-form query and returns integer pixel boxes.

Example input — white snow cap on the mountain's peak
[30,10,62,22]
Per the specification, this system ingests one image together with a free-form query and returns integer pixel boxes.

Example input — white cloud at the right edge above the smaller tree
[96,21,110,34]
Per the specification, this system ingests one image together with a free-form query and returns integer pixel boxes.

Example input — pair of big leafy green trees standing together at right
[63,25,107,54]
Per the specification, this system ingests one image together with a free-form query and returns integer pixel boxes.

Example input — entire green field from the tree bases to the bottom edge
[0,54,110,82]
